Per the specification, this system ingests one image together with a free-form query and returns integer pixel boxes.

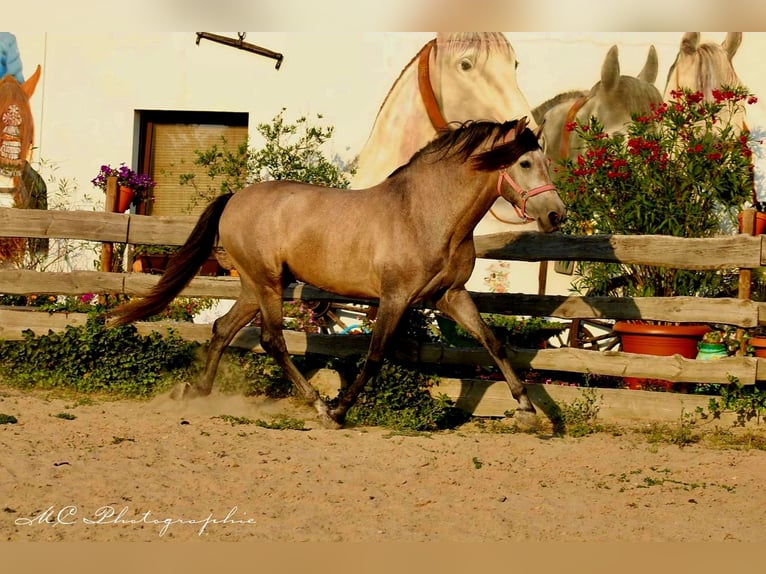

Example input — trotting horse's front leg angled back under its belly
[330,297,408,424]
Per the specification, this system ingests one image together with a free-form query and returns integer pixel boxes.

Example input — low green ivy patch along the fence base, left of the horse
[0,315,196,397]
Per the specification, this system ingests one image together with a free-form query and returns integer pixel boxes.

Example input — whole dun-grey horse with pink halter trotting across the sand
[110,118,565,426]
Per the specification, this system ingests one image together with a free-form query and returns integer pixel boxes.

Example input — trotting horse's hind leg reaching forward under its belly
[260,287,338,428]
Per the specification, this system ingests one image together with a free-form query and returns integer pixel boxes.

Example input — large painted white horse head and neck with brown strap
[351,32,535,188]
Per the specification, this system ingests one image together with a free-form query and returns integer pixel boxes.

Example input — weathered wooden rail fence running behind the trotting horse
[0,208,766,392]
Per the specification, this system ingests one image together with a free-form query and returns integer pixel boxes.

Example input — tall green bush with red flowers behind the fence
[554,88,756,296]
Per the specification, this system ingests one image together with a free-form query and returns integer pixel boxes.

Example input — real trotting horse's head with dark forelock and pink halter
[472,117,566,233]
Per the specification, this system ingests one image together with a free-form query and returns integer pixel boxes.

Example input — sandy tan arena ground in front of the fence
[0,387,766,542]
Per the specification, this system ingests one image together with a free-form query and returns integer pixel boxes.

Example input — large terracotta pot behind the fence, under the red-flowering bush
[614,321,710,389]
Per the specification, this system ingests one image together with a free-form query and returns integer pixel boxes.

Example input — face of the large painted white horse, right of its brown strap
[431,32,531,130]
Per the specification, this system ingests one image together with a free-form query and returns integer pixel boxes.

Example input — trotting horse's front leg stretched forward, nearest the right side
[436,289,536,413]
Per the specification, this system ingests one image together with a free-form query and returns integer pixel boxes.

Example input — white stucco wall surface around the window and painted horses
[10,32,766,300]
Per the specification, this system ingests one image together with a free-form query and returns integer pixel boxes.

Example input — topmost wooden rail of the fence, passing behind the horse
[0,208,766,269]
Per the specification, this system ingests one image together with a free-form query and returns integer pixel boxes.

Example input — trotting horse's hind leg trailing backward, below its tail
[173,296,258,398]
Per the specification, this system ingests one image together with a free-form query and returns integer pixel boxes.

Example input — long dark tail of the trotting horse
[109,193,233,327]
